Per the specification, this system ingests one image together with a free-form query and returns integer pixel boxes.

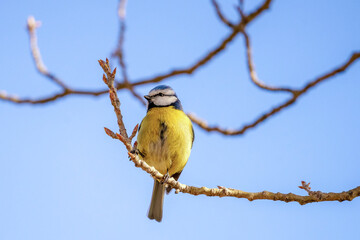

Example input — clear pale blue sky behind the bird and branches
[0,0,360,240]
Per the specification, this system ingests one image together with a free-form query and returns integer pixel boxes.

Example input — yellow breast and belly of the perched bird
[137,106,193,176]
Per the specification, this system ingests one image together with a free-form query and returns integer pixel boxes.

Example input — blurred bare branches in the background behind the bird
[0,0,359,143]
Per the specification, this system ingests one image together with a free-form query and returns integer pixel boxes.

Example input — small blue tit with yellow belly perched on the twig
[137,85,195,222]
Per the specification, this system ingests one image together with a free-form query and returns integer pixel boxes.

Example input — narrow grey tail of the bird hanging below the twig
[148,180,165,222]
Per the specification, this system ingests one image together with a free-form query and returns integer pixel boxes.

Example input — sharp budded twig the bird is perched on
[99,56,360,205]
